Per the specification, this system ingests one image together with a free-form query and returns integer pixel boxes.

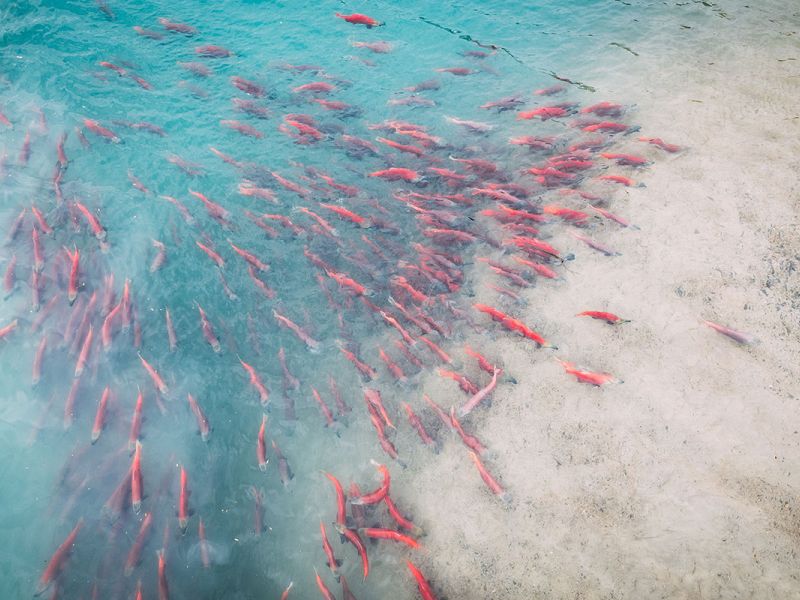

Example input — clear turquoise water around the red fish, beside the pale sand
[0,1,756,598]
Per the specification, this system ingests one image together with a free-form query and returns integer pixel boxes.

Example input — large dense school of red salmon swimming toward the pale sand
[0,2,754,600]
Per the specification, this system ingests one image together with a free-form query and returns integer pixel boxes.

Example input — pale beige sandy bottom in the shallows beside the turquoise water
[404,7,800,599]
